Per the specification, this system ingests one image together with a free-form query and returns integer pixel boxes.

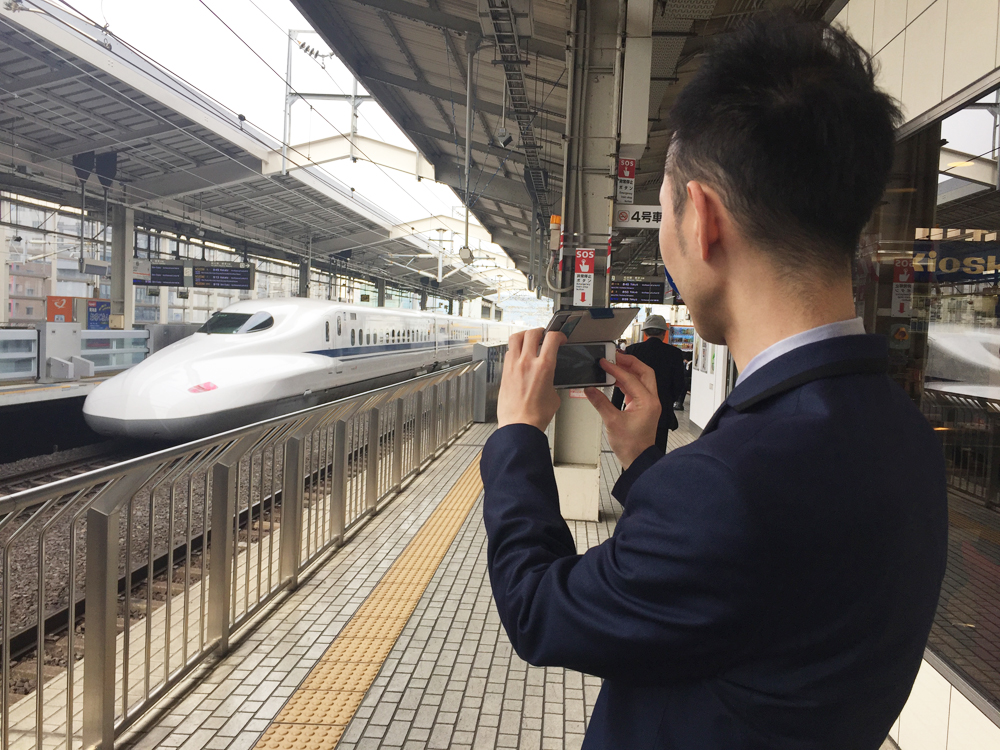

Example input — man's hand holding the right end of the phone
[585,352,660,469]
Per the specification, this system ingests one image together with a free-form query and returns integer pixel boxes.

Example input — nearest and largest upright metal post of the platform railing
[84,505,121,750]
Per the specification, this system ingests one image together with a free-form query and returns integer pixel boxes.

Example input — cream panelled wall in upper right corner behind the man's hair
[835,0,1000,134]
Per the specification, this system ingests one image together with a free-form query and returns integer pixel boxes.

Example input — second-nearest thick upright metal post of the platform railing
[208,458,237,654]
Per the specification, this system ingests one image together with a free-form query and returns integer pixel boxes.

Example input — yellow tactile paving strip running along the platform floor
[255,456,483,750]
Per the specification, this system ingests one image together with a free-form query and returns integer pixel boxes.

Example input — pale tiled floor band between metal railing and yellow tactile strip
[117,425,495,750]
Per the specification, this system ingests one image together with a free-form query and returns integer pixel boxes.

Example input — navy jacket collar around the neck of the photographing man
[702,335,889,434]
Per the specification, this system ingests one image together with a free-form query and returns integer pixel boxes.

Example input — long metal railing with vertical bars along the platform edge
[0,364,477,750]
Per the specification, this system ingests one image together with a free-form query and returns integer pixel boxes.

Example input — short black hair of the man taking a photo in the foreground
[666,12,900,271]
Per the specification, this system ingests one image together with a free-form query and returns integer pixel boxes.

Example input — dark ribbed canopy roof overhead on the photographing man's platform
[292,0,846,280]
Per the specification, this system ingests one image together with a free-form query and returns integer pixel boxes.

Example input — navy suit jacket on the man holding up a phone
[481,336,947,750]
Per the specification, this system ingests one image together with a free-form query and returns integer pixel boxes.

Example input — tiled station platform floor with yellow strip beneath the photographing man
[116,412,699,750]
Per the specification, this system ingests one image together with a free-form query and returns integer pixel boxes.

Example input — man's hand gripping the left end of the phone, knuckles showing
[497,328,566,431]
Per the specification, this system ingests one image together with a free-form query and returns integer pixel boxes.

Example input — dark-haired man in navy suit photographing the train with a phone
[481,15,947,750]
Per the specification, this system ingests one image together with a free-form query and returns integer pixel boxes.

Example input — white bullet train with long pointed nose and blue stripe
[83,298,512,440]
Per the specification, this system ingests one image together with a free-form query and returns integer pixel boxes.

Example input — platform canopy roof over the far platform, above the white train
[0,0,495,297]
